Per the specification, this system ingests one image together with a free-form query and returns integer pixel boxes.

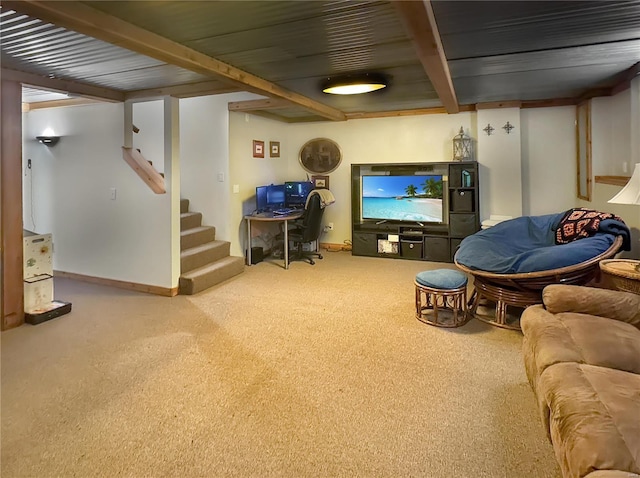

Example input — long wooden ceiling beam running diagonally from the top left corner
[2,0,346,121]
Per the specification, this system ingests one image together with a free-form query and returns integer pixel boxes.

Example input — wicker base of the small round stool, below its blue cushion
[415,282,469,328]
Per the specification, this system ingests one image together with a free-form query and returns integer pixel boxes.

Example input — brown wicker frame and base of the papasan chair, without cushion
[454,236,622,330]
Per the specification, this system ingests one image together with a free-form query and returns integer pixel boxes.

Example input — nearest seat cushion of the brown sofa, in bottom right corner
[538,363,640,478]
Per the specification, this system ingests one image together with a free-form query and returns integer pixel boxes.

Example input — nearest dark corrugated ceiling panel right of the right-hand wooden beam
[433,0,640,60]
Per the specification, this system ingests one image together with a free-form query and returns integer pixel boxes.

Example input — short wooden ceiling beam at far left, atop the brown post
[2,67,125,103]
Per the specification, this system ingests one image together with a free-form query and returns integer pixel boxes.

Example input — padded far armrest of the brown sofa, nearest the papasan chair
[542,284,640,329]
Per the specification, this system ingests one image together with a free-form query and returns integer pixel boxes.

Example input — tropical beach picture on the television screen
[362,175,442,222]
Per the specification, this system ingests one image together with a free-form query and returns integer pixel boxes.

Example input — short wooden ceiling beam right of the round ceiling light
[392,0,460,113]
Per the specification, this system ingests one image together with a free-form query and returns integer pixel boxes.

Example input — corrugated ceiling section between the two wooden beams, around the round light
[84,0,430,104]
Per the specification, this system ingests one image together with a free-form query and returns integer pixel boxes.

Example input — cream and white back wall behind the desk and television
[230,107,592,255]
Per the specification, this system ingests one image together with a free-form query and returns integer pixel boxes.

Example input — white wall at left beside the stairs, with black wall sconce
[23,104,173,287]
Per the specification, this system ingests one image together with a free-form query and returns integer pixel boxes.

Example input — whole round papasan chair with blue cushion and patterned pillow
[454,208,631,330]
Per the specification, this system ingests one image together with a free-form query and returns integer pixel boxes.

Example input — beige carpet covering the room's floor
[1,252,560,478]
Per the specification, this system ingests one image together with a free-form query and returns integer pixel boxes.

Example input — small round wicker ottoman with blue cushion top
[415,269,469,327]
